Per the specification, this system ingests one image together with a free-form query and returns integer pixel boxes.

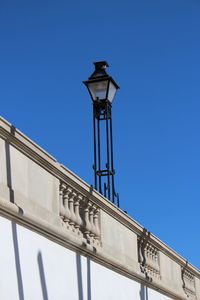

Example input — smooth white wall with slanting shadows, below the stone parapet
[0,217,170,300]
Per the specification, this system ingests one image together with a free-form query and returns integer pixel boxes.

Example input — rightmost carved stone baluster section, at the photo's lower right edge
[181,262,196,300]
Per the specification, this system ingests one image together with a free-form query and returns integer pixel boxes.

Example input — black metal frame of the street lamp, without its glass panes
[84,62,119,207]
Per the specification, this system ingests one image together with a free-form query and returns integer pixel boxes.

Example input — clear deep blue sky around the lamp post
[0,0,200,267]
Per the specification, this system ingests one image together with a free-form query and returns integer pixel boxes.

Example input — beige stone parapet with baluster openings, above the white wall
[0,118,200,300]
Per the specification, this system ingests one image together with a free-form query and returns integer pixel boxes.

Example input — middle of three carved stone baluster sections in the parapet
[138,230,160,281]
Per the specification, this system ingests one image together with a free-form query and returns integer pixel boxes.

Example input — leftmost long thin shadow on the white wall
[12,222,24,300]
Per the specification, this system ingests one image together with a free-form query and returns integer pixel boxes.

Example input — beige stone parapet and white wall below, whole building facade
[0,118,200,300]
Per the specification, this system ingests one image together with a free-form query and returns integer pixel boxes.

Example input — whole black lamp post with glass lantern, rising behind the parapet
[83,61,119,207]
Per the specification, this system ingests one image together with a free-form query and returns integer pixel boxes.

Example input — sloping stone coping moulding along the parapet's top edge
[0,118,200,284]
